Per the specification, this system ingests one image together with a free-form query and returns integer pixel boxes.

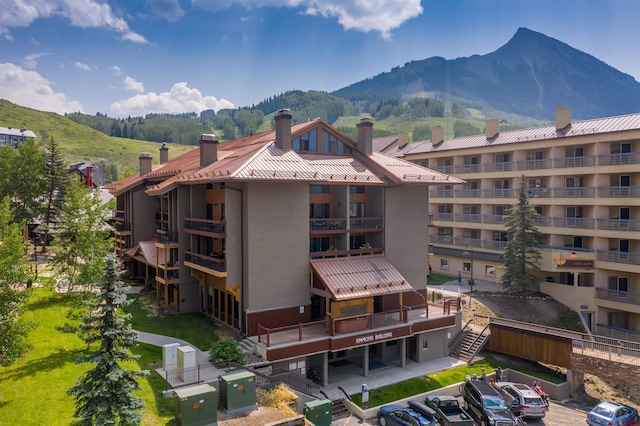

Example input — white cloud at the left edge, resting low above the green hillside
[0,63,83,115]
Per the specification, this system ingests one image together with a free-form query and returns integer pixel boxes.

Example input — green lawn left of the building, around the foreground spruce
[0,288,222,426]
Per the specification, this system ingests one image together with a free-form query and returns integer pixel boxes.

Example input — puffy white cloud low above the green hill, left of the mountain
[110,82,234,116]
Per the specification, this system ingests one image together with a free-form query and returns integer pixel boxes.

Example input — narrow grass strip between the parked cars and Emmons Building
[351,356,564,407]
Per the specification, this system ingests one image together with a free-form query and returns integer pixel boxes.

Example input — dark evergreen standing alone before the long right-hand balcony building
[500,176,542,293]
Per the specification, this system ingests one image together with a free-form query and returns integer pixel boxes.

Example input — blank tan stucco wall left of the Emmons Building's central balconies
[244,182,309,311]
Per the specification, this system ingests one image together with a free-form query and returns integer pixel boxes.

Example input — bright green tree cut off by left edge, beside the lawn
[0,197,34,367]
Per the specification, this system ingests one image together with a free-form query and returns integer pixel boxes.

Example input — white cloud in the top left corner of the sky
[0,0,147,43]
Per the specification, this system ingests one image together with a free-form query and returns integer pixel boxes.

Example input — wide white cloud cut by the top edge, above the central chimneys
[191,0,423,39]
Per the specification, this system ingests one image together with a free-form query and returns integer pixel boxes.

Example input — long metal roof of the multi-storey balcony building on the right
[402,114,640,155]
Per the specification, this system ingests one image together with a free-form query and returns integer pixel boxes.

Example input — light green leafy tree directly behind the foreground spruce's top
[50,181,113,291]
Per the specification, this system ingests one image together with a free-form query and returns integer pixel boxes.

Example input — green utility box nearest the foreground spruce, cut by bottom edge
[174,385,218,426]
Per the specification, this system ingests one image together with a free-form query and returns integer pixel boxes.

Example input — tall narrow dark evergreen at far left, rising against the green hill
[42,136,69,252]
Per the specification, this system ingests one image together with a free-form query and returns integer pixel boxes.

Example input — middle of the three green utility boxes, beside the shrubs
[219,371,258,413]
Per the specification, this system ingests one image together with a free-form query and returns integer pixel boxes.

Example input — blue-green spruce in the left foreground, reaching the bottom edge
[67,257,148,425]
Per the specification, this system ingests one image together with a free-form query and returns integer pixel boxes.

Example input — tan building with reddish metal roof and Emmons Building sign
[108,110,462,384]
